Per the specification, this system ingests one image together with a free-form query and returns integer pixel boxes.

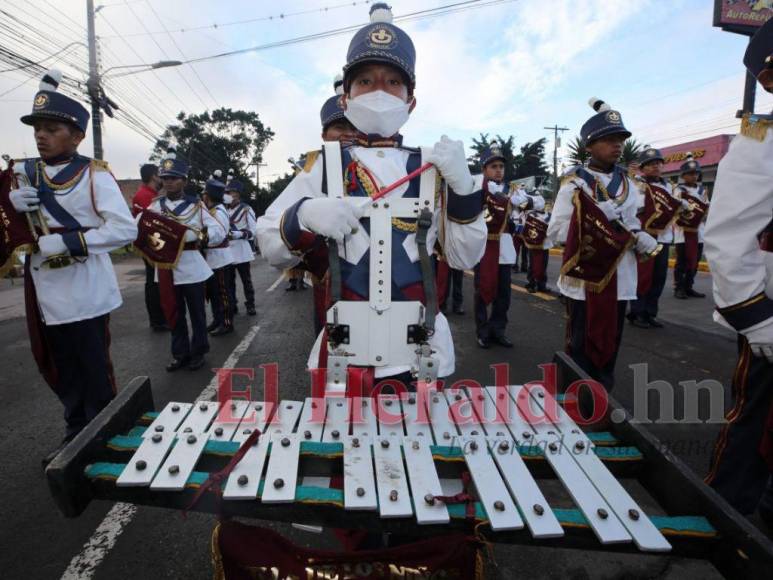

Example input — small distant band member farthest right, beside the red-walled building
[674,153,709,300]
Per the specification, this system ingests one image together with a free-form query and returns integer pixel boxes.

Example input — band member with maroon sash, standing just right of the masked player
[475,147,515,348]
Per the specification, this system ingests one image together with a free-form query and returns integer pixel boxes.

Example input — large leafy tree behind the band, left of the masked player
[151,108,274,189]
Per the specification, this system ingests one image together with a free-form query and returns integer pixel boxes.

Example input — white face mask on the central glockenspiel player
[344,91,411,137]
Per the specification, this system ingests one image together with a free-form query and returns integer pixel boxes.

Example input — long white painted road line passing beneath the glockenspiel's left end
[62,324,262,580]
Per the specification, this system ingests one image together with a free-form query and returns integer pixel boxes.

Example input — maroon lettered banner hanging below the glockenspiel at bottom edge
[211,521,484,580]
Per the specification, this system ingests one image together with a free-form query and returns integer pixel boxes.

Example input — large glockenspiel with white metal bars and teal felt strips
[47,356,773,571]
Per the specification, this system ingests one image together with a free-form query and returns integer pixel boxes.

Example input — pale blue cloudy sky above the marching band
[0,0,773,184]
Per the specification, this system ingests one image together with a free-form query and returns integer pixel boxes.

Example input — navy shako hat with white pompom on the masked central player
[344,2,416,91]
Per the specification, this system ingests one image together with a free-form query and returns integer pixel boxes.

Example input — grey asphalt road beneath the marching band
[0,259,748,579]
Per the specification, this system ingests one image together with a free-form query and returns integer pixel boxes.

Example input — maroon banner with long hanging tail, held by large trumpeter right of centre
[561,194,634,367]
